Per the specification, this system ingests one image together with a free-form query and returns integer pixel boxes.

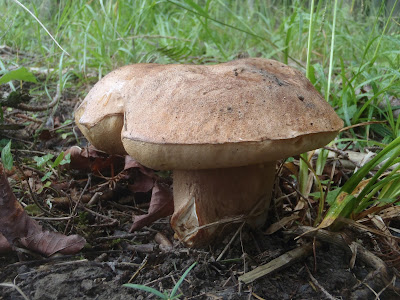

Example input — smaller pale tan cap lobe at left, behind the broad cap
[75,64,164,154]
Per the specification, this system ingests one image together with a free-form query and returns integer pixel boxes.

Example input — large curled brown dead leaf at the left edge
[0,163,86,256]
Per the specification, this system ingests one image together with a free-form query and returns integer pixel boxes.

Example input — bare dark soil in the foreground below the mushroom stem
[0,223,398,300]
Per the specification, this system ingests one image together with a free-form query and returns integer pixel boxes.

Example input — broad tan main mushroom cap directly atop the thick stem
[122,58,343,169]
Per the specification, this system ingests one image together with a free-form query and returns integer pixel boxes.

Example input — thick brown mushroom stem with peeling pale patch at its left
[171,162,275,247]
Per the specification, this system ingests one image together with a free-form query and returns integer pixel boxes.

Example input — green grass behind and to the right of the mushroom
[0,0,400,227]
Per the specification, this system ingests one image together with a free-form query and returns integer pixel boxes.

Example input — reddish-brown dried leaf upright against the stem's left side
[129,182,174,232]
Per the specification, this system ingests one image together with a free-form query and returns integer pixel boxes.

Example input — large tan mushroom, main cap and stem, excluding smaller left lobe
[122,58,343,247]
